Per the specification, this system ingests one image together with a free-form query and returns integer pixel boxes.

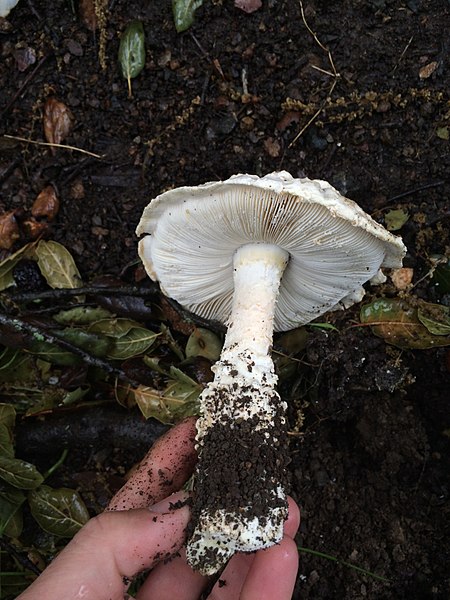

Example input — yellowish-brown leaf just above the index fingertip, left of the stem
[134,369,203,424]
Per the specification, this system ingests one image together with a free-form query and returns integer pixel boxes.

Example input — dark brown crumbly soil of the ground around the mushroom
[0,0,450,600]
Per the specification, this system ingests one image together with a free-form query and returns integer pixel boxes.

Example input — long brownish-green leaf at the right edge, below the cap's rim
[361,298,450,350]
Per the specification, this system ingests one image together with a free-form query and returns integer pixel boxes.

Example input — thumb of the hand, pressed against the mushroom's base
[19,492,189,600]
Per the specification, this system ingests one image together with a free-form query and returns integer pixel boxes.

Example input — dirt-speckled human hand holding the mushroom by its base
[17,418,300,600]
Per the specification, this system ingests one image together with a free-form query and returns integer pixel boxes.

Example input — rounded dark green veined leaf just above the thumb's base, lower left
[28,485,89,537]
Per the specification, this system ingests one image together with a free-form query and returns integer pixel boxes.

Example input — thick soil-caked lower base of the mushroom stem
[187,372,289,575]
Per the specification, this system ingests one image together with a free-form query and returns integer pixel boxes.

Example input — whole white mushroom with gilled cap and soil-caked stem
[136,171,406,575]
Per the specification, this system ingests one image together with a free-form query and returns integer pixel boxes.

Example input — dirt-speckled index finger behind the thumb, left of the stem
[107,417,197,510]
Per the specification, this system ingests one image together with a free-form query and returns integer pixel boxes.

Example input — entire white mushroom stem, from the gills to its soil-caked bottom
[187,244,289,575]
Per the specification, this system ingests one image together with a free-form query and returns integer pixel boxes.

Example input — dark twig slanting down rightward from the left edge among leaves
[0,313,141,387]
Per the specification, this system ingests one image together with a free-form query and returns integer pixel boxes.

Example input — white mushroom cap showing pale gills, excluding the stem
[136,171,406,331]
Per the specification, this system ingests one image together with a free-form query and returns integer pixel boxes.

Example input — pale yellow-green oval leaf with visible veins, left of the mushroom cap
[36,240,82,289]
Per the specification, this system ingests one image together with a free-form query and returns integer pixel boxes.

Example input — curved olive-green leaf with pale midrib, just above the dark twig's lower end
[89,319,159,360]
